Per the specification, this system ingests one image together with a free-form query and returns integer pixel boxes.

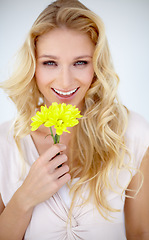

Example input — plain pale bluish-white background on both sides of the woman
[0,0,149,123]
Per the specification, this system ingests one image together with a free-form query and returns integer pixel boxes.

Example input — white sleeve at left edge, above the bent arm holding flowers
[0,120,30,206]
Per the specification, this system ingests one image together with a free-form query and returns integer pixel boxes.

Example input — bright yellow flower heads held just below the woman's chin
[31,102,82,135]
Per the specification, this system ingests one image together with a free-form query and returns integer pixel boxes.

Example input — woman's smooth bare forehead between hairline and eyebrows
[37,28,94,58]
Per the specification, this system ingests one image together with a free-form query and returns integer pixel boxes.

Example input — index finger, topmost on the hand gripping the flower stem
[40,144,66,162]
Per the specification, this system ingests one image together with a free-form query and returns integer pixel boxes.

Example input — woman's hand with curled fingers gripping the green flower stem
[19,144,70,209]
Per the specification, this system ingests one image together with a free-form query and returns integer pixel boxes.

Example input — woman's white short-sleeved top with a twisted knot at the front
[0,112,149,240]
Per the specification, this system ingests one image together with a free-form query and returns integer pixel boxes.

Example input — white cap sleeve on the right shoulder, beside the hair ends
[126,112,149,175]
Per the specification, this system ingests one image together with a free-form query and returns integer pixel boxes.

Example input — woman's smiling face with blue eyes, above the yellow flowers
[35,28,95,110]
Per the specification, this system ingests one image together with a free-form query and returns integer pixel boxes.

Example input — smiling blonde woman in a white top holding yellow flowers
[0,0,149,240]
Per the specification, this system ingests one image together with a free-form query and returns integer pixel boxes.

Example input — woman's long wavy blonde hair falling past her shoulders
[1,0,128,220]
